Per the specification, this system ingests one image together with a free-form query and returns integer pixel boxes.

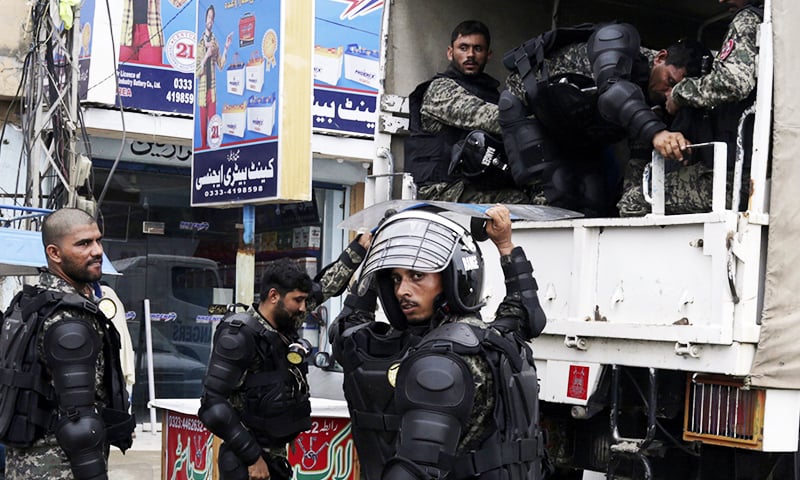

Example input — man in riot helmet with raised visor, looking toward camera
[330,206,546,480]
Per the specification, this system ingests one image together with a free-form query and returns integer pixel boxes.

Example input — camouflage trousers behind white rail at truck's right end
[617,158,720,217]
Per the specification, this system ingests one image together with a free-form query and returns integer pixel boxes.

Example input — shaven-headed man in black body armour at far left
[6,208,130,480]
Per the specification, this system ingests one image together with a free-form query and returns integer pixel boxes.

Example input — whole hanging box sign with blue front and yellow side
[191,0,313,207]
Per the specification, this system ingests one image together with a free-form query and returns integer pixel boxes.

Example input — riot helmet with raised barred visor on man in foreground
[359,210,484,329]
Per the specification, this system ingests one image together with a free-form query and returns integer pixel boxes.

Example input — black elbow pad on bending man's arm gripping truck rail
[597,80,667,141]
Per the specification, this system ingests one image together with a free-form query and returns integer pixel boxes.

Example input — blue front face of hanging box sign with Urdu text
[192,0,282,206]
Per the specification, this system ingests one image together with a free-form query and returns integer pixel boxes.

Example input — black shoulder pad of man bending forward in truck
[586,23,641,88]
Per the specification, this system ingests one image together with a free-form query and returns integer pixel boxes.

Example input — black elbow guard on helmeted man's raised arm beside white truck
[502,247,547,340]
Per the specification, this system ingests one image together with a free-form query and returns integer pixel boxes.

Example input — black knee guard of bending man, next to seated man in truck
[497,90,548,186]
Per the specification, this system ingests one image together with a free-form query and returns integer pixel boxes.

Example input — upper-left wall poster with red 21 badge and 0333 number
[117,0,195,114]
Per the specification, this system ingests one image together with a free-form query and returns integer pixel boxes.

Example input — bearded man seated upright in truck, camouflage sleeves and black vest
[406,20,532,203]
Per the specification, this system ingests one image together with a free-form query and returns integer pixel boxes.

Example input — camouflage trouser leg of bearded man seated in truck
[417,180,546,205]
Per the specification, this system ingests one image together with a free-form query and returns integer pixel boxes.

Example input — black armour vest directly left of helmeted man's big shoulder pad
[339,322,419,480]
